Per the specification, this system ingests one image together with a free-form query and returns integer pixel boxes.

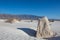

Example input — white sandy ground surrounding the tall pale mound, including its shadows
[0,20,60,40]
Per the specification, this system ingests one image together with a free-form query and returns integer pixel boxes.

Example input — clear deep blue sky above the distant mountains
[0,0,60,19]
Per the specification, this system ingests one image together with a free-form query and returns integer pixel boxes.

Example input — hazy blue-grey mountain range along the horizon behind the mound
[0,14,60,21]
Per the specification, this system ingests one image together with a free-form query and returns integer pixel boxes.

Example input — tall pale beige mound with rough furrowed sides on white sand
[37,17,54,38]
